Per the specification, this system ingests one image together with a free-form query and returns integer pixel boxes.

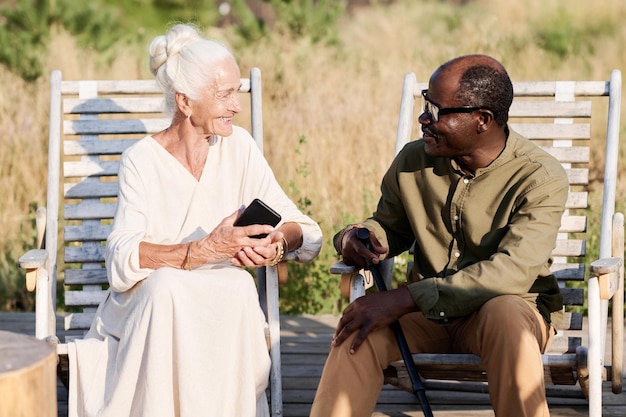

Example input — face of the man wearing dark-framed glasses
[418,70,478,158]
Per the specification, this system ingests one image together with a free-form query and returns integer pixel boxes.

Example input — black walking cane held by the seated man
[356,227,433,417]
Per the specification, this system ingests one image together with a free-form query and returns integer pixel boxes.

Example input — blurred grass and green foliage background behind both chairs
[0,0,626,313]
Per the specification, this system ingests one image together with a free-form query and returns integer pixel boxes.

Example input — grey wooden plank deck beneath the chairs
[0,313,626,417]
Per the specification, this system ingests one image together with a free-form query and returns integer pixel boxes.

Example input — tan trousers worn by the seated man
[310,295,554,417]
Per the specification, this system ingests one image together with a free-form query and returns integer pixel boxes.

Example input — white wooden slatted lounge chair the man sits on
[331,70,624,417]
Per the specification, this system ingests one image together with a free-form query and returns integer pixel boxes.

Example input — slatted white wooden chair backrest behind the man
[395,70,621,352]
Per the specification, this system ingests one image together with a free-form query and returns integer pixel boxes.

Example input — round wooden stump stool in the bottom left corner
[0,331,57,417]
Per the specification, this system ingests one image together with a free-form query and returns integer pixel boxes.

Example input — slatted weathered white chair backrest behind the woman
[45,68,263,338]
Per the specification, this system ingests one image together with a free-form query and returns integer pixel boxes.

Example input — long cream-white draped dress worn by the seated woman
[68,127,322,417]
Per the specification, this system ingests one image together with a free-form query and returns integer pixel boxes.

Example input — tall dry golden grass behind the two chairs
[0,0,626,308]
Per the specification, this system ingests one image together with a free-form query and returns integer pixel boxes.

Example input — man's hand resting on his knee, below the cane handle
[332,287,417,353]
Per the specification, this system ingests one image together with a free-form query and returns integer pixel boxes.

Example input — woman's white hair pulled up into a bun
[148,24,235,117]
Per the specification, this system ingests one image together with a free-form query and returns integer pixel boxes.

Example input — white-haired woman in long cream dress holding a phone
[70,25,322,417]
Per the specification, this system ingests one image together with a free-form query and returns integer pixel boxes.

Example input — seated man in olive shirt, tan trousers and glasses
[311,55,568,417]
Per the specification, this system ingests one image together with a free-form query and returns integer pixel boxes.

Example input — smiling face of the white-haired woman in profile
[191,58,241,136]
